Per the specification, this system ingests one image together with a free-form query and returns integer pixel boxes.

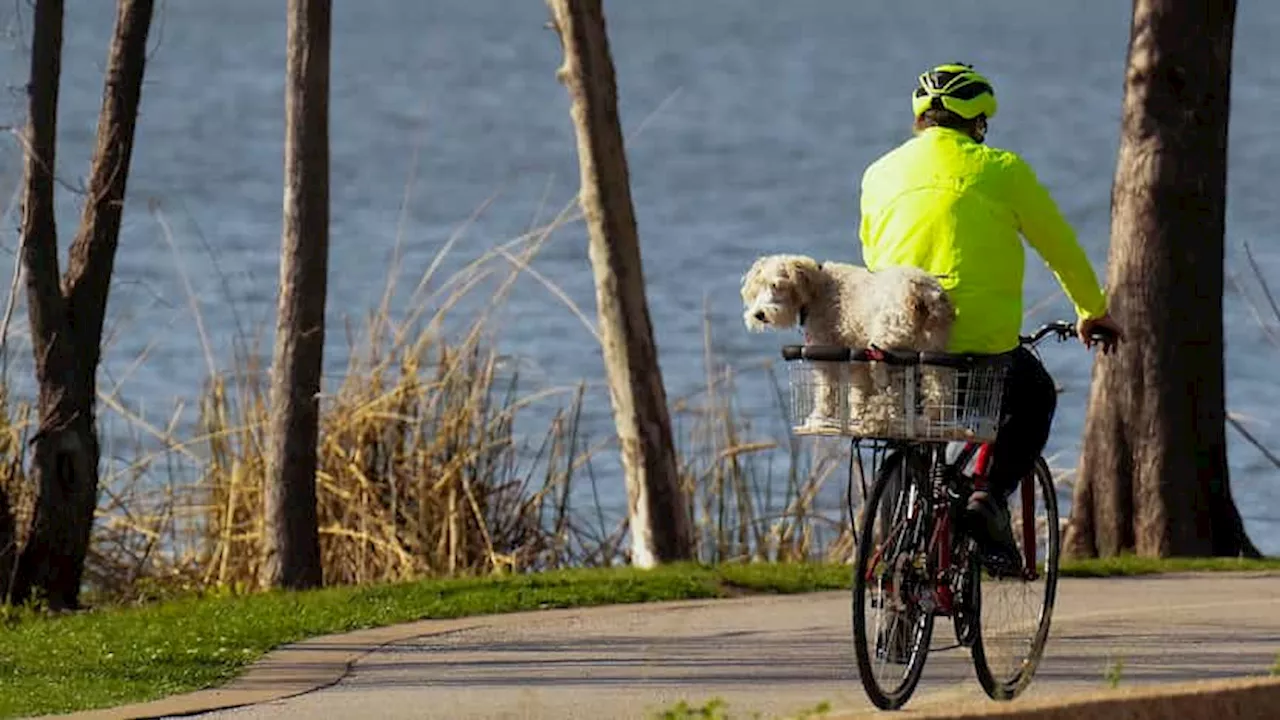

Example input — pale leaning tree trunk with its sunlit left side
[548,0,692,568]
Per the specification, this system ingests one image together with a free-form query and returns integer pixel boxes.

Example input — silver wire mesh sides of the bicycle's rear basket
[787,360,1007,442]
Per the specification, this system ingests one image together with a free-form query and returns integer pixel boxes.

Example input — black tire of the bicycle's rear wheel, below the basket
[852,452,934,710]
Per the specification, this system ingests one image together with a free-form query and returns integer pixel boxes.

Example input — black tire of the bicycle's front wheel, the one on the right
[969,457,1061,701]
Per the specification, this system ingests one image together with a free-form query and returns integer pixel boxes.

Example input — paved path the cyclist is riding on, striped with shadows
[189,574,1280,720]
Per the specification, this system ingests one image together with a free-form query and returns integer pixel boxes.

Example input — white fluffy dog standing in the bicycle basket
[742,255,955,434]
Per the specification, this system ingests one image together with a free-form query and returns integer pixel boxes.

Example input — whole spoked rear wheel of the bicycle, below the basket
[852,450,933,710]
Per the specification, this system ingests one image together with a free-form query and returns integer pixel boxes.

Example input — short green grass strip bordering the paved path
[0,557,1280,717]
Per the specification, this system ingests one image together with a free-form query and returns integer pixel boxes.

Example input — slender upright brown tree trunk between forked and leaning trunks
[264,0,330,588]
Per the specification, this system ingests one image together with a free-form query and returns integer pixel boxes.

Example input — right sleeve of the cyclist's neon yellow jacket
[1010,155,1107,318]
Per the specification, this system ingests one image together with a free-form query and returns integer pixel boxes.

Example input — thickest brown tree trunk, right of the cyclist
[1066,0,1258,557]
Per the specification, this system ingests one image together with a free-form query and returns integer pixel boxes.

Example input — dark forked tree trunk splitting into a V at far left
[13,0,154,609]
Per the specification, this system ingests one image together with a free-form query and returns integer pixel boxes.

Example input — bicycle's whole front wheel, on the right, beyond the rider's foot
[970,459,1060,700]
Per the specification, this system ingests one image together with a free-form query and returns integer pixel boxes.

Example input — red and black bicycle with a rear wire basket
[782,322,1115,710]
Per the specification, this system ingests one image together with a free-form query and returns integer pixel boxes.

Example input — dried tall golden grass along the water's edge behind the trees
[17,172,847,601]
